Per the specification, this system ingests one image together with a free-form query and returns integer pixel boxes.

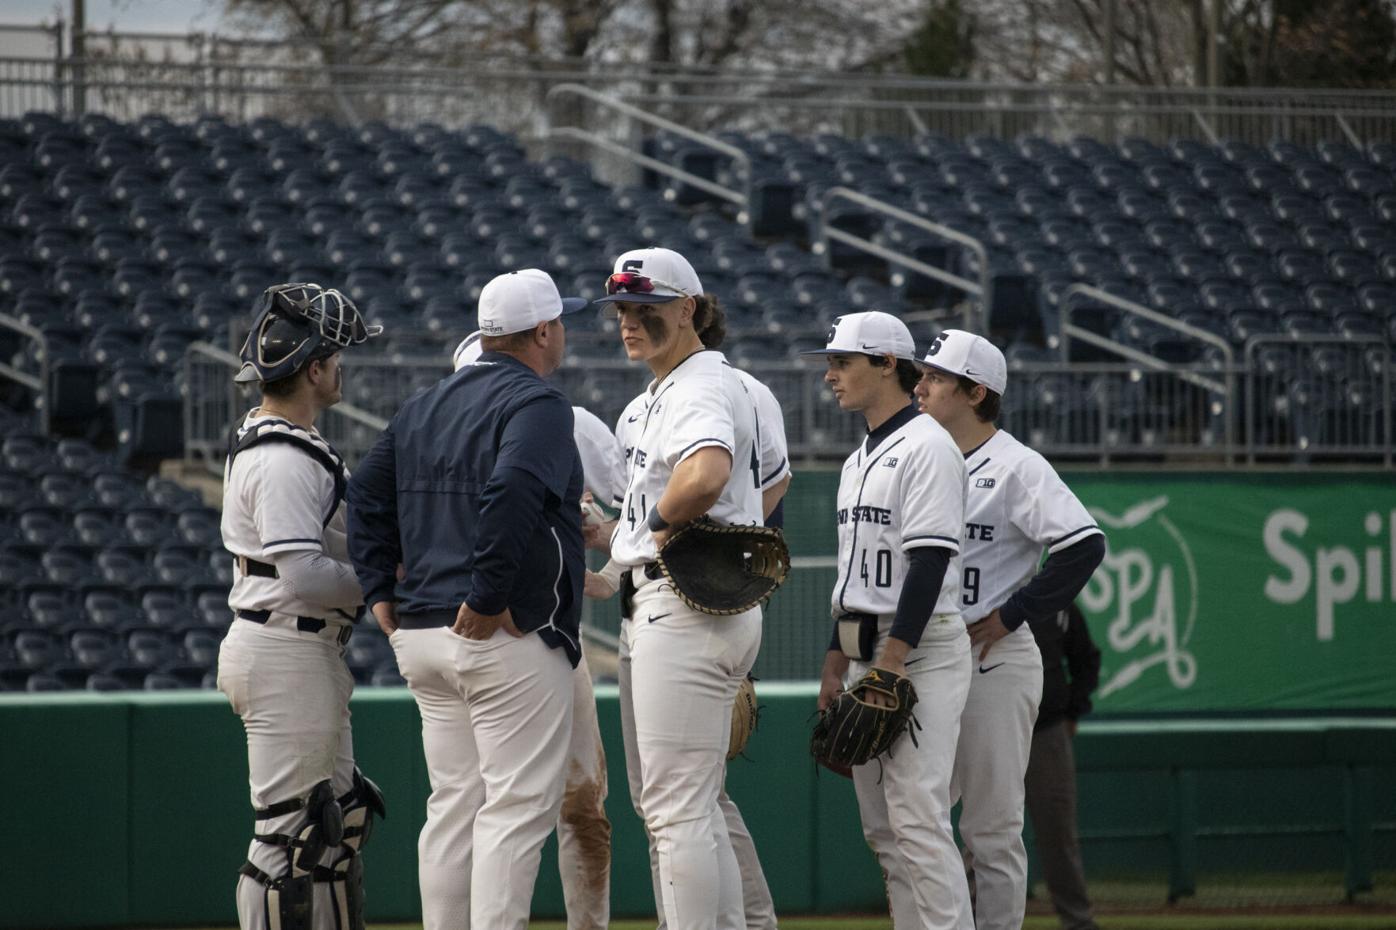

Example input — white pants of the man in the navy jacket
[389,627,574,930]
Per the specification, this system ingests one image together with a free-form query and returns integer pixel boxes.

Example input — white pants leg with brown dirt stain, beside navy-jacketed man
[557,658,610,930]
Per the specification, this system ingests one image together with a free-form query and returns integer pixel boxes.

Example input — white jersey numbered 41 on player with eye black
[611,349,761,566]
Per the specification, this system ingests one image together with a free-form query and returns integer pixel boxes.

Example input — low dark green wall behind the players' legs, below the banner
[0,684,1396,927]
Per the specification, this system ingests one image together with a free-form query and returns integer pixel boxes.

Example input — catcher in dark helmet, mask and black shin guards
[218,283,384,930]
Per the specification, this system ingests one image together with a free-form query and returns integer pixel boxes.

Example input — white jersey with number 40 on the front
[832,413,965,614]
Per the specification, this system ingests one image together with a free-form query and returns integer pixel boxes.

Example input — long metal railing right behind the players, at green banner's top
[184,331,1396,472]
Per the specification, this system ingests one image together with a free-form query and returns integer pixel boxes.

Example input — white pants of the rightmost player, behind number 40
[951,624,1043,930]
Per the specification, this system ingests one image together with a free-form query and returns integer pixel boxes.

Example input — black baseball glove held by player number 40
[810,667,920,772]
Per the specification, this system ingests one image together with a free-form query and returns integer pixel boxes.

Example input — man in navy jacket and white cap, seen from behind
[348,270,586,930]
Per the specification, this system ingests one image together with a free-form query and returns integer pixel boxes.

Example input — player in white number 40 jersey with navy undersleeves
[808,311,970,930]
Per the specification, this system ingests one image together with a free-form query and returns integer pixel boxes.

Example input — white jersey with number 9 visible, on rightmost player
[960,430,1100,623]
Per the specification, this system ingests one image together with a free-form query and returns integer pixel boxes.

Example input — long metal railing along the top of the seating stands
[0,32,1396,144]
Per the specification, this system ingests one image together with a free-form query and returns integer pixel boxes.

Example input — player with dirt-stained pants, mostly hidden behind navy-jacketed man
[452,330,614,930]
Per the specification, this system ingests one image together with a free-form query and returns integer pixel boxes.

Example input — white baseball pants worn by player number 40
[845,613,969,930]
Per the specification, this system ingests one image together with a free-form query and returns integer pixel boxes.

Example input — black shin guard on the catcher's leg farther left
[239,779,345,930]
